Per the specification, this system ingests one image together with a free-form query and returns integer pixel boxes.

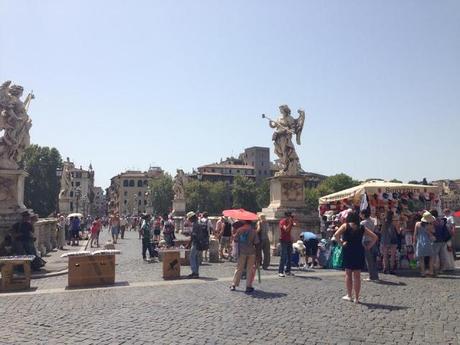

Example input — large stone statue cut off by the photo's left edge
[0,81,34,169]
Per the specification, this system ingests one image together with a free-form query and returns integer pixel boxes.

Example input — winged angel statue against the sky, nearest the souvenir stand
[262,105,305,176]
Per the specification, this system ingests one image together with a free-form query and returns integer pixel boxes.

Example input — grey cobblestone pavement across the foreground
[0,228,460,345]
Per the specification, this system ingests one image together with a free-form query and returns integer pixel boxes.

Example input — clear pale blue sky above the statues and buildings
[0,0,460,187]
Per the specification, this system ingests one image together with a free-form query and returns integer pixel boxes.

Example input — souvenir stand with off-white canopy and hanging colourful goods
[319,181,441,268]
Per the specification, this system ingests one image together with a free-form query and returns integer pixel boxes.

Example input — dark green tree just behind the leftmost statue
[20,145,62,217]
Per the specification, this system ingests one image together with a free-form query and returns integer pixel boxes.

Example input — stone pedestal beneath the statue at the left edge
[0,170,27,244]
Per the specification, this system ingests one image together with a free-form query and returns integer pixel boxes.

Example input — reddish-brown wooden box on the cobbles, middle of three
[68,255,115,287]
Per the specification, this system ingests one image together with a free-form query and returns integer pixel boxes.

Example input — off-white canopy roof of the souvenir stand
[319,181,440,205]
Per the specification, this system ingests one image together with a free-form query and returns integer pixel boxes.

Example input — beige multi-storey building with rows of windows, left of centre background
[108,167,164,215]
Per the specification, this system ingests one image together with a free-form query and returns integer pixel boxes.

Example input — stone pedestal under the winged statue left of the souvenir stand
[262,176,319,245]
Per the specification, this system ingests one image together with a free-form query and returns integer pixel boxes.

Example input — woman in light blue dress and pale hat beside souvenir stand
[414,211,435,277]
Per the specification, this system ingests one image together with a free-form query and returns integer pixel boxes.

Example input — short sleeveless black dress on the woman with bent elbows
[342,225,365,270]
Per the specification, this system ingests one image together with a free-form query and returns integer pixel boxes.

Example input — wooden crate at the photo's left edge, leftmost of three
[0,259,31,292]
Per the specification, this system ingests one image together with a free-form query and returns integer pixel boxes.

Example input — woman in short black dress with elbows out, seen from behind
[334,212,378,303]
